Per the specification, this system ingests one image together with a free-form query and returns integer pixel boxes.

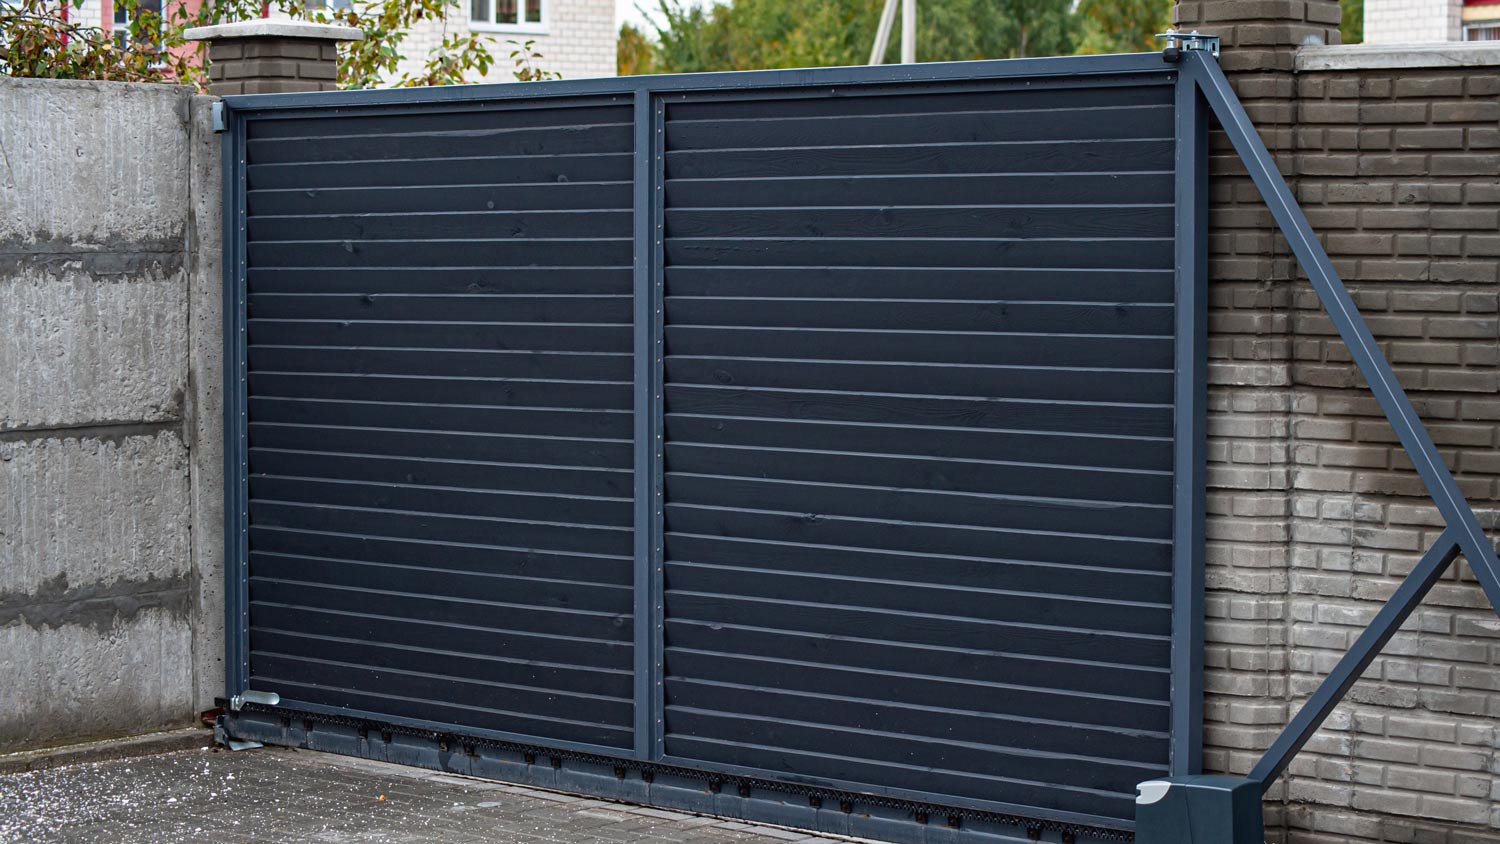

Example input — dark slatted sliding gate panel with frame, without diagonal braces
[225,54,1205,841]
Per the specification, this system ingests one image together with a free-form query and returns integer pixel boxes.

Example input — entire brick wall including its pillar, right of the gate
[1176,0,1500,844]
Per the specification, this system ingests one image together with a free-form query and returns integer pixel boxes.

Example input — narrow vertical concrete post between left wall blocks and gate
[188,96,224,711]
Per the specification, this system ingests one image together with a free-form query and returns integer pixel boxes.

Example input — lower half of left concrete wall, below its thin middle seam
[0,430,194,751]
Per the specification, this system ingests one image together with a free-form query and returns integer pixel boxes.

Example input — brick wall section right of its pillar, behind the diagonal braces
[1287,51,1500,844]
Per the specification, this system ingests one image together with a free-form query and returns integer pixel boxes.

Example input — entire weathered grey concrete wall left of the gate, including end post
[0,78,222,751]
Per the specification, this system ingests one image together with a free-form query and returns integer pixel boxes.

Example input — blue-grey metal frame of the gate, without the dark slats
[222,54,1208,840]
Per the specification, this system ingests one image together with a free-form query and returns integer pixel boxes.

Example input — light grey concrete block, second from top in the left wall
[0,252,188,430]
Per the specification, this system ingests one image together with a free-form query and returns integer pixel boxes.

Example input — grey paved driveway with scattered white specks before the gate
[0,748,876,844]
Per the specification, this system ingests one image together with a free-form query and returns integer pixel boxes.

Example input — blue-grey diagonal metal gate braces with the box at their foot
[1136,44,1500,844]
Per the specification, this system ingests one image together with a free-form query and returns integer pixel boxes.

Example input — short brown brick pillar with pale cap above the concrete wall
[185,18,365,96]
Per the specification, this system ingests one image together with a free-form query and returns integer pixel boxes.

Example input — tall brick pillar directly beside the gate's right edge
[1173,0,1341,841]
